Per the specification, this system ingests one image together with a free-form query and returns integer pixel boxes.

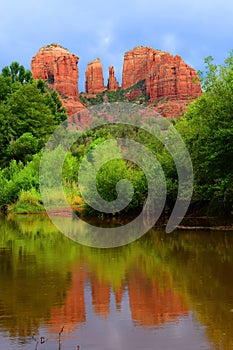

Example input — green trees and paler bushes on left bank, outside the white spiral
[0,62,67,211]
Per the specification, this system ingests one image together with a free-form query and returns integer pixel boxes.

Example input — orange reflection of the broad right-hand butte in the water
[128,277,188,326]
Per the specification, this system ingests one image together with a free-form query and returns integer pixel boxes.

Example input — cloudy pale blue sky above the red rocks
[0,0,233,91]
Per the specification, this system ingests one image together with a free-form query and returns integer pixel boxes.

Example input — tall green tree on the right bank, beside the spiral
[177,53,233,212]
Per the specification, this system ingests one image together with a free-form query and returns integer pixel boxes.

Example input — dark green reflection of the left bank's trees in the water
[0,219,71,343]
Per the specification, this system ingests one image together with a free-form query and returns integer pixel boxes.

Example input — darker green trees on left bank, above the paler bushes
[0,62,67,168]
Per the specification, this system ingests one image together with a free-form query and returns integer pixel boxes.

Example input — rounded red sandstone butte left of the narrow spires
[31,44,84,115]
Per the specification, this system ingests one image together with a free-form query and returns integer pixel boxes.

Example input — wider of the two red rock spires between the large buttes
[85,58,105,93]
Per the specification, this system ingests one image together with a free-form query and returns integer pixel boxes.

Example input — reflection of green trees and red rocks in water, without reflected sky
[0,217,233,349]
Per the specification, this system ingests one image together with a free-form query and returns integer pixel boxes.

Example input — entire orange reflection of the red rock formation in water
[47,258,188,334]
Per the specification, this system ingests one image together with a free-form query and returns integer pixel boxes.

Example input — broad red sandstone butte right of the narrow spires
[122,47,201,116]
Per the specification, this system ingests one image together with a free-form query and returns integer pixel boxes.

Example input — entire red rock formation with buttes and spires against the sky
[31,44,201,117]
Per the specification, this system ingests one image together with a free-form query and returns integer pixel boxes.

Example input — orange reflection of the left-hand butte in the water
[50,267,86,334]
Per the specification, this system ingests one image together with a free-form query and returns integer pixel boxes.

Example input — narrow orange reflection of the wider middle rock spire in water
[91,277,110,318]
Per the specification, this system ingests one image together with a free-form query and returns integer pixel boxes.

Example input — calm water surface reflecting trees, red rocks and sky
[0,216,233,350]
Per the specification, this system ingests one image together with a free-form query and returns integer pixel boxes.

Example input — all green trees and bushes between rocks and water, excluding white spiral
[0,54,233,219]
